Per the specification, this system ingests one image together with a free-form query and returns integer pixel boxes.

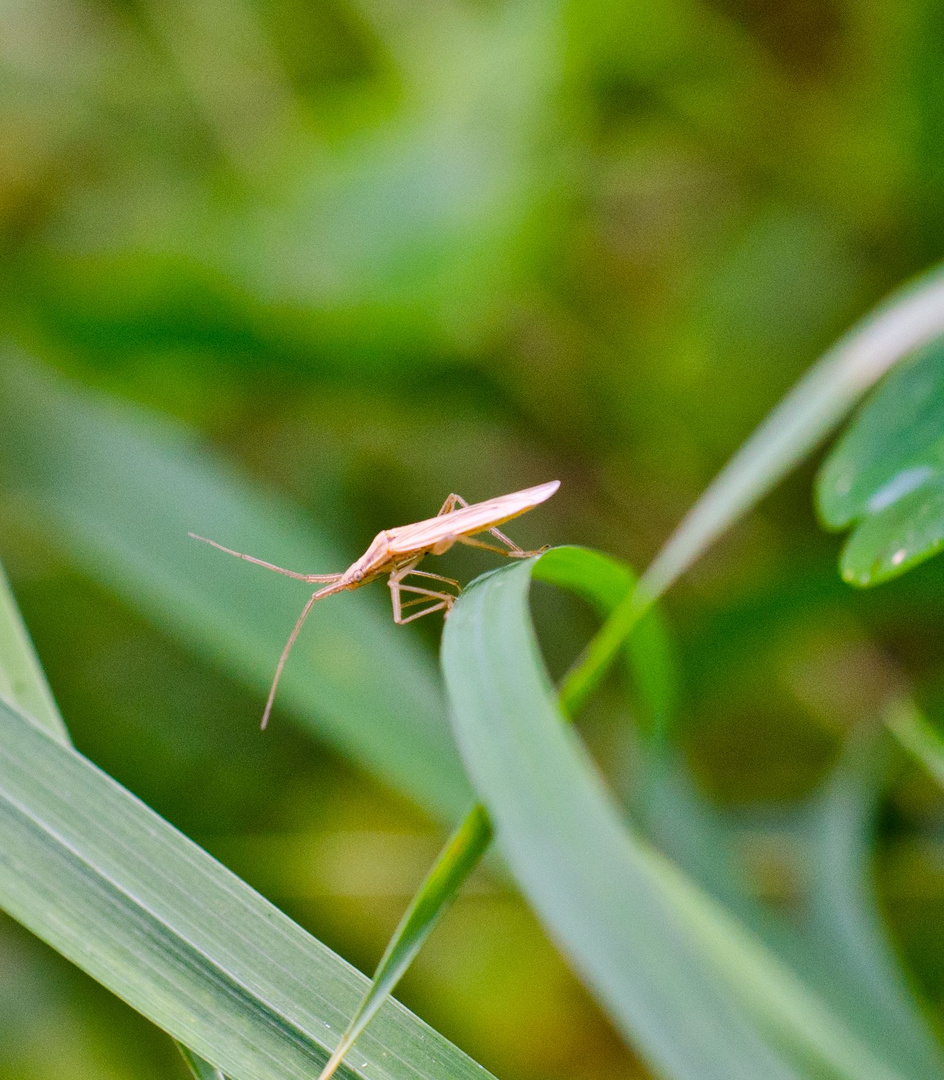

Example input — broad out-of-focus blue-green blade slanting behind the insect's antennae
[0,356,472,819]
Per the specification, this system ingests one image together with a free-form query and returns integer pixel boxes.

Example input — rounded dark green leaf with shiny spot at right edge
[817,339,944,586]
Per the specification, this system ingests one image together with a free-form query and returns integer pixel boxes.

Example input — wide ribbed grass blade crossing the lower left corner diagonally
[0,702,496,1080]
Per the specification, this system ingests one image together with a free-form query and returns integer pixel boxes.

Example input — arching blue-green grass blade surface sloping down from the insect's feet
[443,564,928,1080]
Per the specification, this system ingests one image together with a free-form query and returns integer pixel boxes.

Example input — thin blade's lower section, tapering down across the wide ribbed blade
[318,805,491,1080]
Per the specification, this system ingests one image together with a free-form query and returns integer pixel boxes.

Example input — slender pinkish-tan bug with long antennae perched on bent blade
[190,480,561,728]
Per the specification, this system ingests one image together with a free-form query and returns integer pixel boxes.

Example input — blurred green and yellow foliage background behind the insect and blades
[0,0,944,1080]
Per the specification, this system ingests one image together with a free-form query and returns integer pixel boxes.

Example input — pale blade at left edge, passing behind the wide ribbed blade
[0,565,226,1080]
